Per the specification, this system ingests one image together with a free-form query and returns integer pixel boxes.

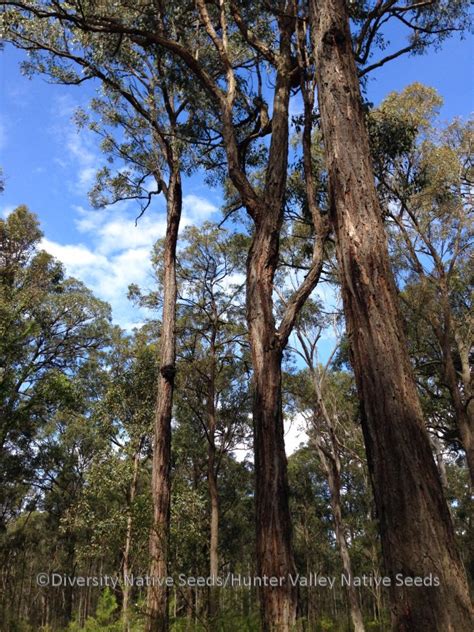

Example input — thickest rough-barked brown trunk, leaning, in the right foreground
[310,0,472,632]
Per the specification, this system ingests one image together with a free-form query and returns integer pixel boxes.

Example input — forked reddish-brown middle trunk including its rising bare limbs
[218,18,300,632]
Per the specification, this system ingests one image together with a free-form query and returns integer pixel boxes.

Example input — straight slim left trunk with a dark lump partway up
[145,172,182,632]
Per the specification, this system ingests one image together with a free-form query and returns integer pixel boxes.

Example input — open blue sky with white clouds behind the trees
[0,30,474,328]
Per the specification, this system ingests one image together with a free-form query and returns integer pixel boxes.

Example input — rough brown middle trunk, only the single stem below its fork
[247,224,297,632]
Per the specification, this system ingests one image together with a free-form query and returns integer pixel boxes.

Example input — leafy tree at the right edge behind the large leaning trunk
[374,84,474,480]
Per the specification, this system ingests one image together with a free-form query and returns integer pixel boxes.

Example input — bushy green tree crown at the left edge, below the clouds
[0,206,110,522]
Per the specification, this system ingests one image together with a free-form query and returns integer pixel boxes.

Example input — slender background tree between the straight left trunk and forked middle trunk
[173,224,250,620]
